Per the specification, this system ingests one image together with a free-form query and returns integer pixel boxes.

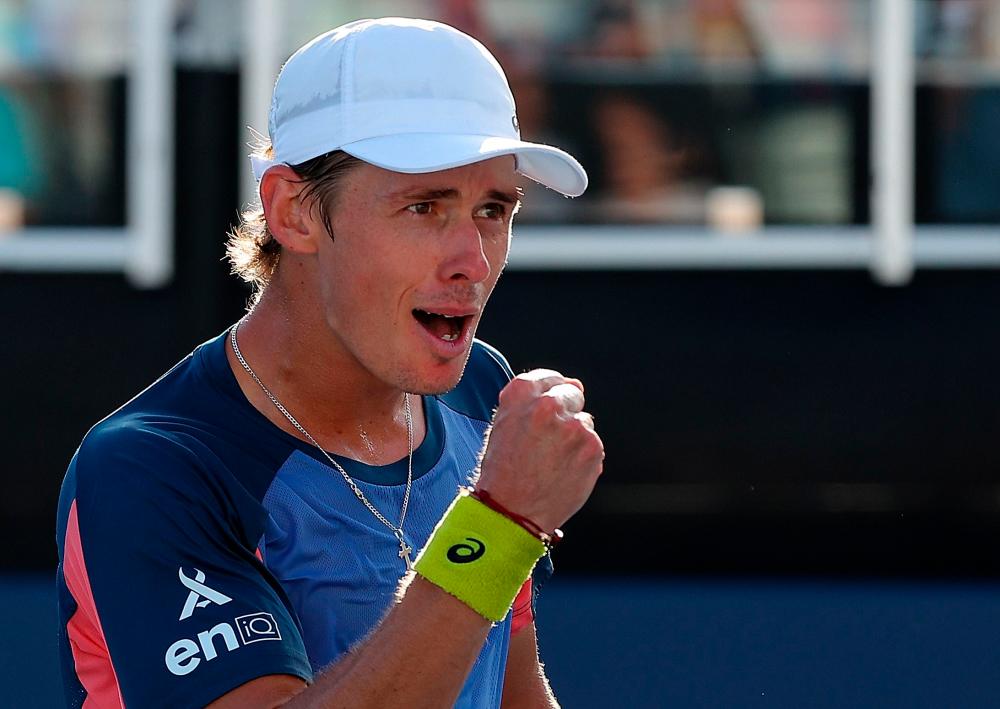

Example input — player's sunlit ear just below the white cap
[260,165,325,254]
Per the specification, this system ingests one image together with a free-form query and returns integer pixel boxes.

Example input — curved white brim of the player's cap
[340,133,587,197]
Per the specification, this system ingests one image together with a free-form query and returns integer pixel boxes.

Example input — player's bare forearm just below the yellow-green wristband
[285,576,490,709]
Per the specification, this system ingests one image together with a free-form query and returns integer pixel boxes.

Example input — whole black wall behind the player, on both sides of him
[7,72,1000,575]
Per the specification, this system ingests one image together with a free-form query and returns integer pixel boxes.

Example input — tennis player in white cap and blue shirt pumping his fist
[57,19,604,708]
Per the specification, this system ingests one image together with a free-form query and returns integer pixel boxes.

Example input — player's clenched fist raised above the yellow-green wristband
[477,369,604,532]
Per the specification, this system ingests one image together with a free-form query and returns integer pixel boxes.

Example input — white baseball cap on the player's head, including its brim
[251,17,587,197]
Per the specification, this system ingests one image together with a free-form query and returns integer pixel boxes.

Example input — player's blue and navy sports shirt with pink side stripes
[57,333,551,707]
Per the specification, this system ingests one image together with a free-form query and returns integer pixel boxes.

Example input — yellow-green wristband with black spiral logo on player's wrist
[414,489,545,622]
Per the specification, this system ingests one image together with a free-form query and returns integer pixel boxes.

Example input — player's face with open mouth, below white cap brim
[318,156,518,394]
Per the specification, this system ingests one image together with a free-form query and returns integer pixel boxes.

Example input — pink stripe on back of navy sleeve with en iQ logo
[63,500,125,709]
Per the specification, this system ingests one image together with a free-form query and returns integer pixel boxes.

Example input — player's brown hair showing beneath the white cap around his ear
[226,145,361,301]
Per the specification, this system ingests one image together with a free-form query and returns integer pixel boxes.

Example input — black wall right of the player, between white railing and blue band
[481,271,1000,575]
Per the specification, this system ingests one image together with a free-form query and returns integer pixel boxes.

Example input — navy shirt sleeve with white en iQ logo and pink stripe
[60,430,312,707]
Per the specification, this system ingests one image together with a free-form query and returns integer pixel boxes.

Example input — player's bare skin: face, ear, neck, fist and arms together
[211,156,604,707]
